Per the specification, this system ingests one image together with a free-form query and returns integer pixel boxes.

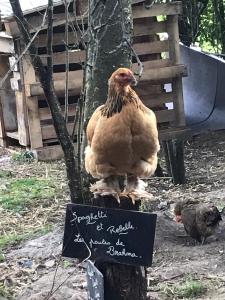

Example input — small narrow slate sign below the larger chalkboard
[87,260,104,300]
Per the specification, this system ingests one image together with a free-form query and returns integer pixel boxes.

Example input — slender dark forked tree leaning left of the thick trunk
[10,0,82,203]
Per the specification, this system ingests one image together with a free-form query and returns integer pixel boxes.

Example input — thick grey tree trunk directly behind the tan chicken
[81,0,132,199]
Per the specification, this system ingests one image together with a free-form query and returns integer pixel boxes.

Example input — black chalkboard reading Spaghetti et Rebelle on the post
[62,204,156,266]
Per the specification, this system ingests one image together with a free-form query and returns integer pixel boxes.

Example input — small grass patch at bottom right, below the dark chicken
[162,278,206,299]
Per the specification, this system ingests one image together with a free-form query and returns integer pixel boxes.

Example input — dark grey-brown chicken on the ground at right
[174,200,222,244]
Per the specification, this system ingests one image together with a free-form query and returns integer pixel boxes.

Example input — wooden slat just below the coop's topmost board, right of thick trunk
[133,19,167,36]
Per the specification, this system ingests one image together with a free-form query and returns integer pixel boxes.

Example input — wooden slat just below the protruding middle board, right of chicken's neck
[141,92,174,108]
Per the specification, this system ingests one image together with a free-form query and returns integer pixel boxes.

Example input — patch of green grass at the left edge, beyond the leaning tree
[0,178,56,212]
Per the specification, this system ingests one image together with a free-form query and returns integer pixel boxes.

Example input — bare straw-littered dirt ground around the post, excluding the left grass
[0,131,225,300]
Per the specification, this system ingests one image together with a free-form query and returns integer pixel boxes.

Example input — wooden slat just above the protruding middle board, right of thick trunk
[133,40,169,55]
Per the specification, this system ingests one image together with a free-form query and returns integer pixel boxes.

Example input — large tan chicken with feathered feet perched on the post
[85,68,160,204]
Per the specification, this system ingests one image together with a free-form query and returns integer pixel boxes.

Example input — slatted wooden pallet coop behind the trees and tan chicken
[0,0,187,183]
